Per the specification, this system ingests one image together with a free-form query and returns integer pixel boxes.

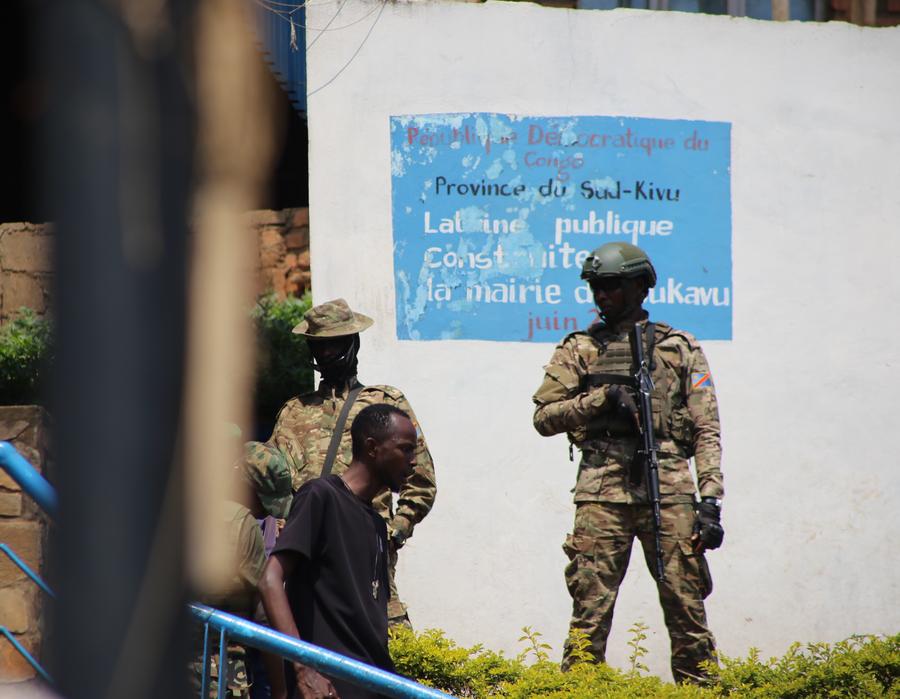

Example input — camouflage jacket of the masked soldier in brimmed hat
[268,382,437,537]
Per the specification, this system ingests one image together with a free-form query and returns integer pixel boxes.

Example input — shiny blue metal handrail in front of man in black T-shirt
[188,604,450,699]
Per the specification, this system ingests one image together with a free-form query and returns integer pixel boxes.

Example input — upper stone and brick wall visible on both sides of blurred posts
[0,208,311,324]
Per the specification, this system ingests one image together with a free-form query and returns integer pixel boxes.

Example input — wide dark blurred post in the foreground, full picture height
[38,0,194,699]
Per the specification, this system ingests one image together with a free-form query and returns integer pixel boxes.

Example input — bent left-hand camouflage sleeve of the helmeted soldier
[532,338,606,437]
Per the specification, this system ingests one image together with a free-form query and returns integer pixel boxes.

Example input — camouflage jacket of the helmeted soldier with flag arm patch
[533,323,724,503]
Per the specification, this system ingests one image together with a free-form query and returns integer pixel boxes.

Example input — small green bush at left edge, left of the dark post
[0,306,53,405]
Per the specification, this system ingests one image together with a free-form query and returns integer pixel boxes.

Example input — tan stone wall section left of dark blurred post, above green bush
[0,223,53,323]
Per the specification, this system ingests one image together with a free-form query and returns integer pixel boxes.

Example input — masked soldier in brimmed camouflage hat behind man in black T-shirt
[268,299,437,625]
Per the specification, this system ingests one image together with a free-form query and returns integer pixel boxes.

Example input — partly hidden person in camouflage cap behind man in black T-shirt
[190,442,292,699]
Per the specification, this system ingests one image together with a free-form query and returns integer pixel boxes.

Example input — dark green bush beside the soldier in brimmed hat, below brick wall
[251,292,313,420]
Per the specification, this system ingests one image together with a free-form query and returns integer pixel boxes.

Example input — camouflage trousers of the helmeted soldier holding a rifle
[563,503,715,682]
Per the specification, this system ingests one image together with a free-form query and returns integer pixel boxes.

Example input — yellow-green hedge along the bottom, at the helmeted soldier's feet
[390,624,900,699]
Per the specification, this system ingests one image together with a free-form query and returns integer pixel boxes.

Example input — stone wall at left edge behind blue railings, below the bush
[0,405,51,682]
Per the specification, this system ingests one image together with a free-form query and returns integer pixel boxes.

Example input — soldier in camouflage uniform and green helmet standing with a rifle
[534,243,724,682]
